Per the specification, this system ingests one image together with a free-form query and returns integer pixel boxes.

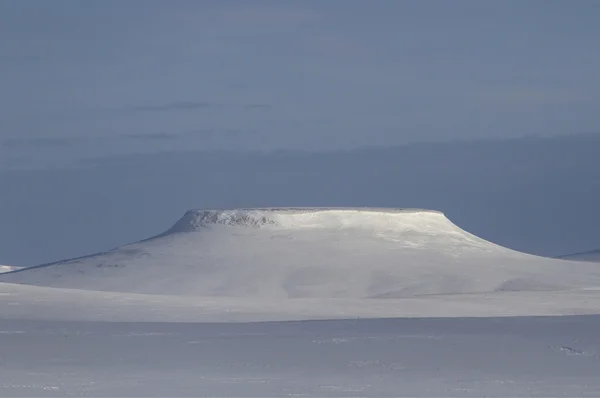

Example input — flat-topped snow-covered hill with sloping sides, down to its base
[0,208,600,299]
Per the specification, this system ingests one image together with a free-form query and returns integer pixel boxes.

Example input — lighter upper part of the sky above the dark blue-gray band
[0,0,600,168]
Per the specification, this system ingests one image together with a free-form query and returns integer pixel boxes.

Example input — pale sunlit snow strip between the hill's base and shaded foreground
[0,283,600,322]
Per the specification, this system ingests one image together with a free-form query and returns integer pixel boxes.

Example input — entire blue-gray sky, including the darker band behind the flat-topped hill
[0,0,600,265]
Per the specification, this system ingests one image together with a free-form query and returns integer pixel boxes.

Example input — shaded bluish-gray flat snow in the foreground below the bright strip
[0,316,600,397]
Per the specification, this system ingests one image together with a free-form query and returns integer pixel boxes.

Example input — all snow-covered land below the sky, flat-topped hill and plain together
[0,209,600,397]
